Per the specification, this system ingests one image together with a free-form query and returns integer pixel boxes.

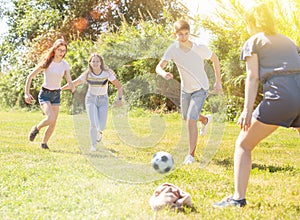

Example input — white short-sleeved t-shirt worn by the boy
[162,41,212,93]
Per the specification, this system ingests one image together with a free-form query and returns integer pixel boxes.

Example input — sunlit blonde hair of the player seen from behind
[246,3,276,35]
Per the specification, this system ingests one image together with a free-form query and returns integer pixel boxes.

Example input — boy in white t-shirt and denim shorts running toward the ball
[156,20,222,164]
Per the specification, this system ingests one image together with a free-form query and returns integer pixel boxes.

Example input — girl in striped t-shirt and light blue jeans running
[61,54,123,151]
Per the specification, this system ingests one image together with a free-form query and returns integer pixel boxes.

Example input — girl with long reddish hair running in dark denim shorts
[25,39,75,149]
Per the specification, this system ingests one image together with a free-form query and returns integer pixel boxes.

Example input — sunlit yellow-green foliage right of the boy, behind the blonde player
[195,0,300,116]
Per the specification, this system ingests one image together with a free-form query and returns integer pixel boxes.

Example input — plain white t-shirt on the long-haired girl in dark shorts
[42,60,70,90]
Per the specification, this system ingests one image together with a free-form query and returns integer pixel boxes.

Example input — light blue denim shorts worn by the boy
[180,89,208,121]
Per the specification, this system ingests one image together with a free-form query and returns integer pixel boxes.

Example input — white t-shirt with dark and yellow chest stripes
[79,70,116,95]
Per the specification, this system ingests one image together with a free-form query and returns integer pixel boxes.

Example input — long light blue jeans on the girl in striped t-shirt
[85,94,108,146]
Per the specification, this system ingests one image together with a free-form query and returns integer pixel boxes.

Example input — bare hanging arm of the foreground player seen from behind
[238,54,259,131]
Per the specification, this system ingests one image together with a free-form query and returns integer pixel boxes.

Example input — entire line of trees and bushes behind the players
[0,0,300,120]
